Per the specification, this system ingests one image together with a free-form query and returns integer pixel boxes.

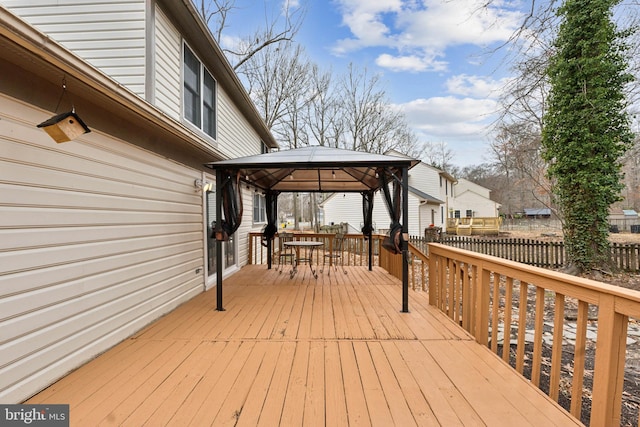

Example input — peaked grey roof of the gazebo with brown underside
[206,146,418,192]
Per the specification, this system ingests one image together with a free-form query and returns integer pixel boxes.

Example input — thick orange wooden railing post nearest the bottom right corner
[591,295,629,426]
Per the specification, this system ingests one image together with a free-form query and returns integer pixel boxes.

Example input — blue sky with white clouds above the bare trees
[215,0,530,167]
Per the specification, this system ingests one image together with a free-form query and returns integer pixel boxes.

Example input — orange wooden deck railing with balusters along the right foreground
[429,244,640,426]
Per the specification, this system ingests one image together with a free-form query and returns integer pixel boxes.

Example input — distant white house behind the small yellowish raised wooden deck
[449,178,500,218]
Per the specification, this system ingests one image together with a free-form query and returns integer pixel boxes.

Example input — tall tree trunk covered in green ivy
[542,0,633,272]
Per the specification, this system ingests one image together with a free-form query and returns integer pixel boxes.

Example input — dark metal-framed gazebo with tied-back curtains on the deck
[206,146,418,312]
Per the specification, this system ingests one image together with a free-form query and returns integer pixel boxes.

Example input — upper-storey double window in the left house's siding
[183,44,216,139]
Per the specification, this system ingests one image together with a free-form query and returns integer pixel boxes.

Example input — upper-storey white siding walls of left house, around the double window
[0,0,261,158]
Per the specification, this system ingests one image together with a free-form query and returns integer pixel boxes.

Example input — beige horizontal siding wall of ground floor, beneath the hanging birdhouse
[0,95,204,402]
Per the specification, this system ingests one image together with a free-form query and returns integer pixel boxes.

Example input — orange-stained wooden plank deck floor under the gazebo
[27,266,581,426]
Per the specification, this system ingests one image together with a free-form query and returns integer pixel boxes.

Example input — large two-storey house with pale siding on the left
[0,0,277,403]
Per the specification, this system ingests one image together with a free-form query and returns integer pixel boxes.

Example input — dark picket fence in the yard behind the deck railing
[410,236,640,272]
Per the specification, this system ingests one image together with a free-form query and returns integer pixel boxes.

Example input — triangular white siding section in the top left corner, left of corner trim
[0,0,146,98]
